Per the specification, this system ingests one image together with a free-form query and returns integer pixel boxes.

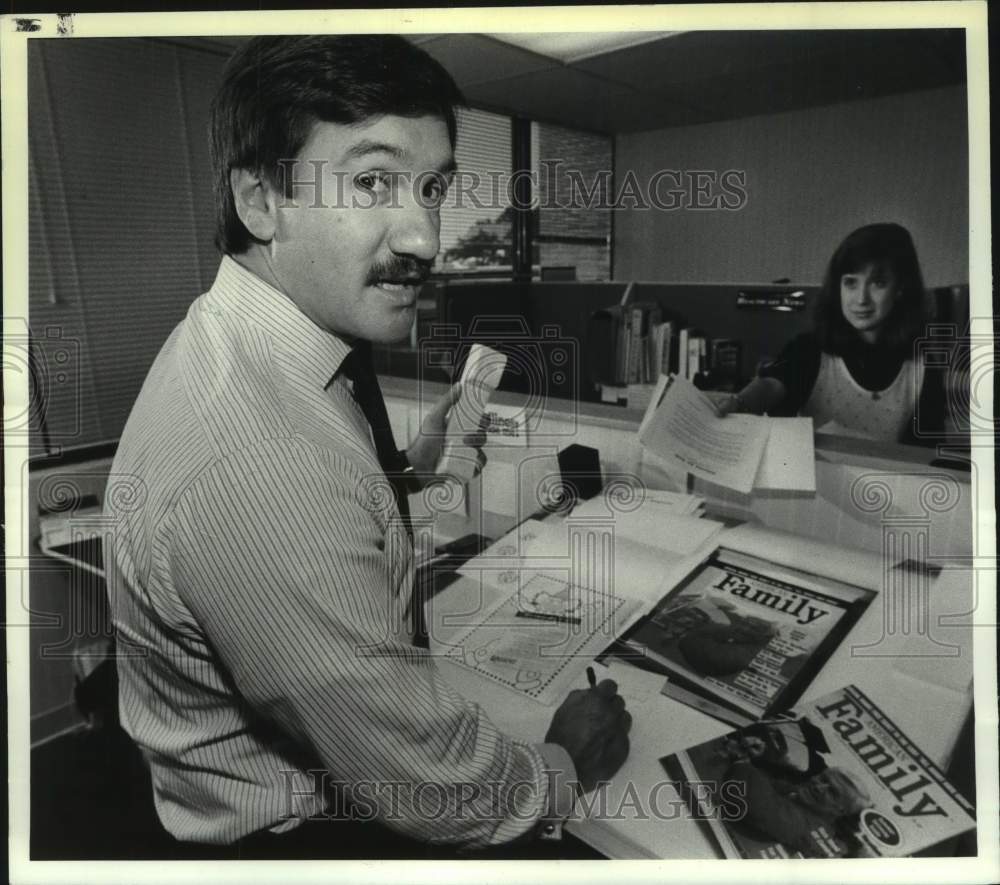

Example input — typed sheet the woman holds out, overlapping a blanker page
[639,378,768,494]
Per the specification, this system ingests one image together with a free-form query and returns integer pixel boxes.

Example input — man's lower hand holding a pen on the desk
[545,679,632,793]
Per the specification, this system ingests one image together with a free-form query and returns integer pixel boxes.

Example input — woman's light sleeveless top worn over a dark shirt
[800,353,924,442]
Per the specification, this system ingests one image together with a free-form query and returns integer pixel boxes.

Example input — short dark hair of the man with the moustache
[210,35,465,255]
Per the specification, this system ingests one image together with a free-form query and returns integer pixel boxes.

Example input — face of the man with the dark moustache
[267,115,454,343]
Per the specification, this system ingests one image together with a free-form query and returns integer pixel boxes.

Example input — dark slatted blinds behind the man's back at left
[28,38,226,446]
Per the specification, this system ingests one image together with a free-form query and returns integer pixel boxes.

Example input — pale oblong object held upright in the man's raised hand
[437,344,510,481]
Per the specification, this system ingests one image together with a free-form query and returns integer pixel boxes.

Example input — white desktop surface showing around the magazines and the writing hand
[427,517,973,859]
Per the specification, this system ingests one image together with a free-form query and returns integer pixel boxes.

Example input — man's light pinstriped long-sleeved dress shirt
[105,258,575,846]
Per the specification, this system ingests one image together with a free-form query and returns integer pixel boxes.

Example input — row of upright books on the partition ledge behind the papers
[589,301,742,390]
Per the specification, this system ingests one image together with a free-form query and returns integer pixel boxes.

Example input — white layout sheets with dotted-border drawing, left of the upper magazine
[435,498,722,704]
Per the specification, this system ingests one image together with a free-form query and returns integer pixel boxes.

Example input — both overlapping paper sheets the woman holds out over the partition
[639,375,816,494]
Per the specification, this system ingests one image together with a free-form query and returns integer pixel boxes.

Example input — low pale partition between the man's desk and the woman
[383,378,976,564]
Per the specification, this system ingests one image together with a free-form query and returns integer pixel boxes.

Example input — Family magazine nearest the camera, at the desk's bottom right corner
[660,685,976,858]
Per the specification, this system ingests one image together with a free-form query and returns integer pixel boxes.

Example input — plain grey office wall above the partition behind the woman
[613,87,969,286]
